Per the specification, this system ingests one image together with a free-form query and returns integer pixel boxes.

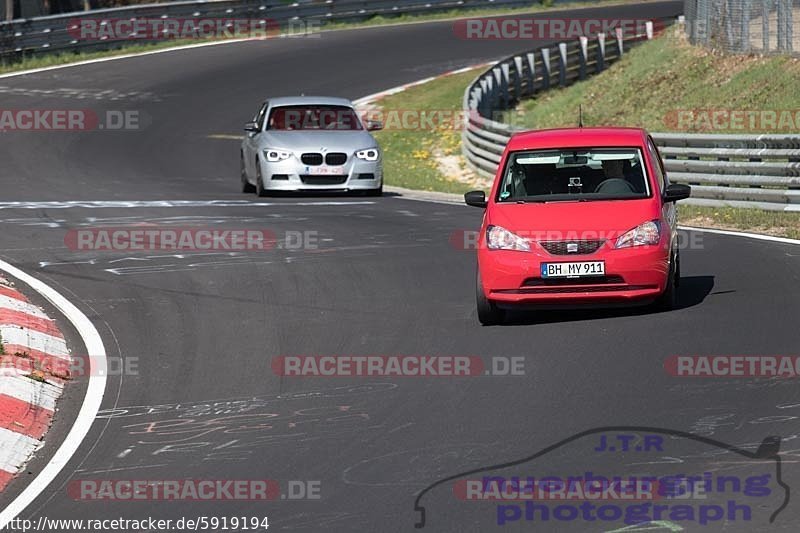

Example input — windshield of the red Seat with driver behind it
[497,148,650,202]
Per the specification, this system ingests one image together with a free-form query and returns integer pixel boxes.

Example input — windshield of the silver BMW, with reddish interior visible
[267,105,362,131]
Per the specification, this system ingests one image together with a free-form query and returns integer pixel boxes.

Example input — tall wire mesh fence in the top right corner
[684,0,800,54]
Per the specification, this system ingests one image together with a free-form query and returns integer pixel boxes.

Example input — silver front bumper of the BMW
[259,156,383,191]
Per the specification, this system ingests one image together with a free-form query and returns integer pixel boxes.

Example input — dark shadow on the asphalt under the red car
[503,276,720,326]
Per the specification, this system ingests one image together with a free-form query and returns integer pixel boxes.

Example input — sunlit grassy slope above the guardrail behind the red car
[515,31,800,133]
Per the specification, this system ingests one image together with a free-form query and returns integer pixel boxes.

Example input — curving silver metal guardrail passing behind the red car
[462,17,800,212]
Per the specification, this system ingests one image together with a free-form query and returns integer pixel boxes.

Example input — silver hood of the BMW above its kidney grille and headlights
[258,130,378,153]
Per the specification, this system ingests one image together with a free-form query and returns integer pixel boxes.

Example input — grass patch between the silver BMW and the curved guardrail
[375,71,478,193]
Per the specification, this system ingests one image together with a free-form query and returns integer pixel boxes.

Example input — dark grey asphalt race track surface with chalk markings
[0,2,800,531]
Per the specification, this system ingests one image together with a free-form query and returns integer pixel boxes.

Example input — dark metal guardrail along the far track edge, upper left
[0,0,567,62]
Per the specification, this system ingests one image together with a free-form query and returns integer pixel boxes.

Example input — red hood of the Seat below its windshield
[487,198,661,240]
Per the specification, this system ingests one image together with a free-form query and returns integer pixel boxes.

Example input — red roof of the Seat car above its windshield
[508,127,647,151]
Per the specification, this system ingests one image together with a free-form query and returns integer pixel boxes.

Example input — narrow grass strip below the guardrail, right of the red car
[680,204,800,239]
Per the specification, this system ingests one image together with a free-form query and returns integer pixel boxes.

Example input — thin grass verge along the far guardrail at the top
[0,0,637,74]
